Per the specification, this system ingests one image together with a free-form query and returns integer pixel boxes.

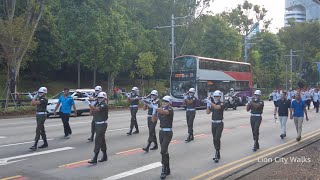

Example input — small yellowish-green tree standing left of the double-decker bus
[131,52,157,93]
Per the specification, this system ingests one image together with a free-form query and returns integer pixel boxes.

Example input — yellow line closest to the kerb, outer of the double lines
[206,132,320,180]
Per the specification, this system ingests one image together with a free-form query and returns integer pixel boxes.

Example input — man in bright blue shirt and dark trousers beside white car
[53,88,77,139]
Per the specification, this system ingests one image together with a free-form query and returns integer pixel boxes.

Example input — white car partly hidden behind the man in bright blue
[47,89,94,117]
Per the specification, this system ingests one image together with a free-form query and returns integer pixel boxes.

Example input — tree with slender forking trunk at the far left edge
[0,0,46,108]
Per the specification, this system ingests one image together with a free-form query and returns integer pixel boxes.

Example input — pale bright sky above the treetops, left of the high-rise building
[210,0,285,33]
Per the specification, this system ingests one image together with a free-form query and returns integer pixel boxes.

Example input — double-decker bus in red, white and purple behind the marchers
[170,55,253,107]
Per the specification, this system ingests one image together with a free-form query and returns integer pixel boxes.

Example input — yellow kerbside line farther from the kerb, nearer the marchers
[191,129,320,180]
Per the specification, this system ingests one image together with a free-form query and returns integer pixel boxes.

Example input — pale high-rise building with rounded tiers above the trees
[284,0,320,26]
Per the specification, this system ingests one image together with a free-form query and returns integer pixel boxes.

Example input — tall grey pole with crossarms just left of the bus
[155,1,189,94]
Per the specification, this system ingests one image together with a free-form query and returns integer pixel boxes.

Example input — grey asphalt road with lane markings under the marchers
[0,102,320,180]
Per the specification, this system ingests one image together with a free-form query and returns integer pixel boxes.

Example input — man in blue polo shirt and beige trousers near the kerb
[290,92,309,141]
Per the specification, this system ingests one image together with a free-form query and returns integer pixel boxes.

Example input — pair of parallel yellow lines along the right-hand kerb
[191,129,320,180]
